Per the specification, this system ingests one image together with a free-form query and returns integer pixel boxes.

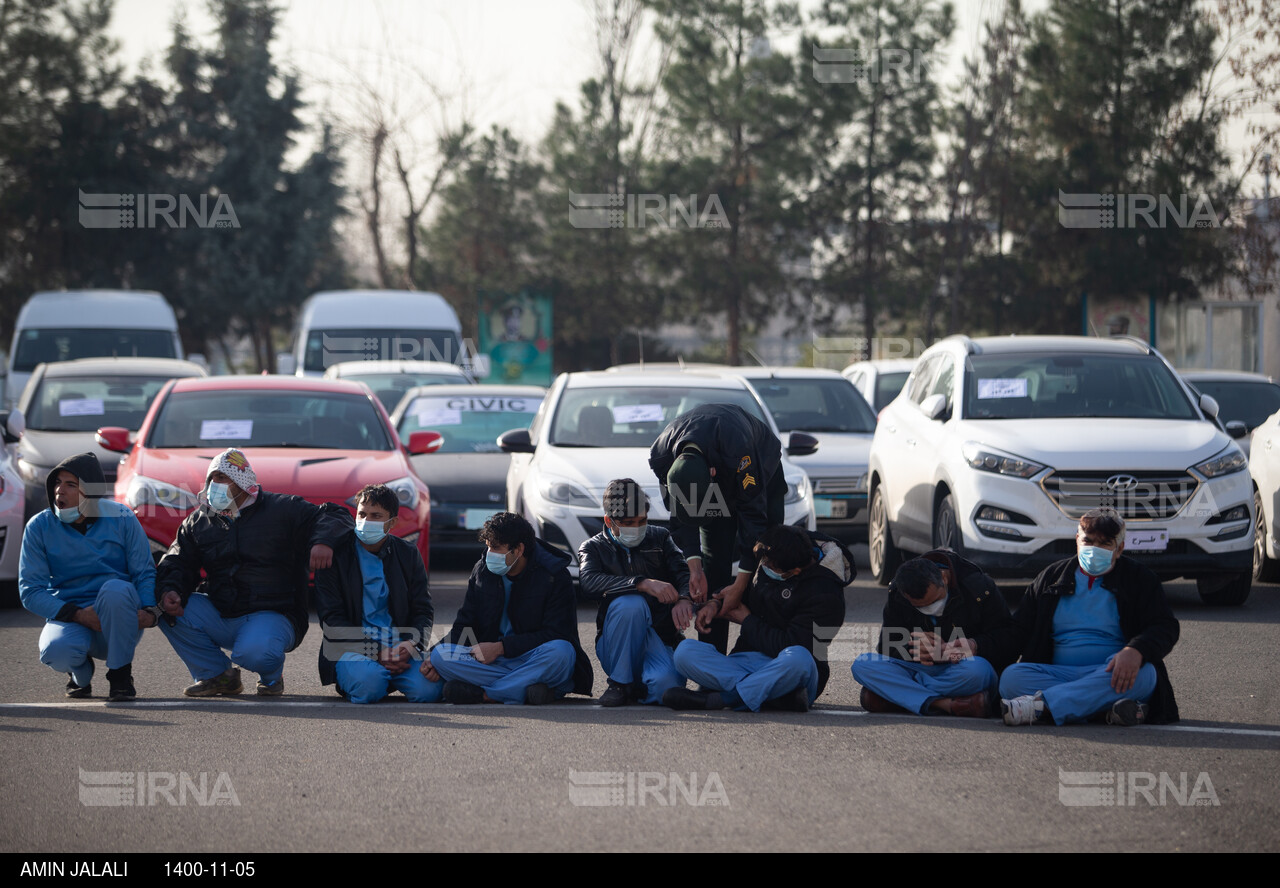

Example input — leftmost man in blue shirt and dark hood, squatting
[18,453,159,702]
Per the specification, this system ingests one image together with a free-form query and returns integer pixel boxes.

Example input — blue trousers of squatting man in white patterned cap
[160,592,293,685]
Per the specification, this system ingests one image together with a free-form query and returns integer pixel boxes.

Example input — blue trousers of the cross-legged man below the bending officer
[675,638,818,713]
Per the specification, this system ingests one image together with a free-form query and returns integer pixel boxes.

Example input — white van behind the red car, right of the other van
[279,290,472,376]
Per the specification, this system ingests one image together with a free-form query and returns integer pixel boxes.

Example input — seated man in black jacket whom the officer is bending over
[662,525,856,713]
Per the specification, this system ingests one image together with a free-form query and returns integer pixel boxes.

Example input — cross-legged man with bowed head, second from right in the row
[852,549,1018,718]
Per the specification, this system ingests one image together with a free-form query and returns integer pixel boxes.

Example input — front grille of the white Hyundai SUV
[1041,472,1199,521]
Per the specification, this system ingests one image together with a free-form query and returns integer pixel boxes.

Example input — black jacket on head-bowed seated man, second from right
[876,549,1021,674]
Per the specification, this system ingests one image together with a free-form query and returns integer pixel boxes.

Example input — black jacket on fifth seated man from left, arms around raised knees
[577,525,689,647]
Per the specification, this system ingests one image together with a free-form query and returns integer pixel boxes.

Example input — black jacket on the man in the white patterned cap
[156,490,355,650]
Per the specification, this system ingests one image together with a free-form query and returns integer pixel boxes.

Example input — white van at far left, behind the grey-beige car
[4,290,183,408]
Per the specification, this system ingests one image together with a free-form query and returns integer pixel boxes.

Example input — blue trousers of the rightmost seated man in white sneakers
[1000,659,1156,724]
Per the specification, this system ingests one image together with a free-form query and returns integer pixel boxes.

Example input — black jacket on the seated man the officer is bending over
[733,534,858,695]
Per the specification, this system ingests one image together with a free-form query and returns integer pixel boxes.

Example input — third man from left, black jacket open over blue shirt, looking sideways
[316,484,443,702]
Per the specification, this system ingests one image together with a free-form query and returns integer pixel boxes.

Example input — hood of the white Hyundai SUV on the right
[954,417,1231,471]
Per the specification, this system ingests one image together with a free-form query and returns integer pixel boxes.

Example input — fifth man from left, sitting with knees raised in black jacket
[577,479,694,706]
